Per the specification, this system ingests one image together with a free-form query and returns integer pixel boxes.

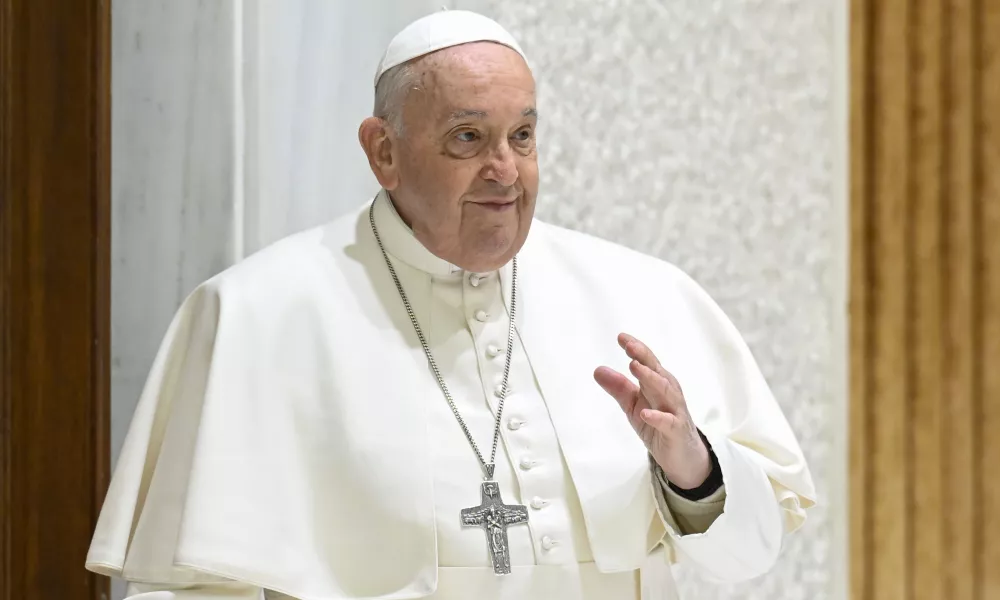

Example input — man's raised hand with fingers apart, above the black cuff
[594,333,712,489]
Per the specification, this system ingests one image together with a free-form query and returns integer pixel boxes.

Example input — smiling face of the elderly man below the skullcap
[389,42,538,272]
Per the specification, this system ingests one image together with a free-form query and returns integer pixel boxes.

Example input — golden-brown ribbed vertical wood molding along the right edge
[850,0,1000,600]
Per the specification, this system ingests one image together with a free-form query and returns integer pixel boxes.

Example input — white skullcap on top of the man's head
[375,10,528,85]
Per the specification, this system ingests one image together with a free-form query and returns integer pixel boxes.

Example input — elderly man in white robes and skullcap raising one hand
[88,11,814,600]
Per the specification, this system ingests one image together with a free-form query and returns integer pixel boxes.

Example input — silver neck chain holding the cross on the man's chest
[368,198,517,480]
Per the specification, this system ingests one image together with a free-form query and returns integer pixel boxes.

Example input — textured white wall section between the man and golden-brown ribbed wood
[489,0,847,600]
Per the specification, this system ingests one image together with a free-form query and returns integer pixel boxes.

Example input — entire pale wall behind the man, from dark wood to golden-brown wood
[112,0,846,600]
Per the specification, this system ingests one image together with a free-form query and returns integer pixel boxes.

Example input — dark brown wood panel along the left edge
[0,0,110,600]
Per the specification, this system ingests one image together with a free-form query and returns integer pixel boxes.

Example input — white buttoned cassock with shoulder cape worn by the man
[87,192,814,600]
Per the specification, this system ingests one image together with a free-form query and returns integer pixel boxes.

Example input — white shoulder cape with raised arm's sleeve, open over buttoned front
[87,199,815,600]
